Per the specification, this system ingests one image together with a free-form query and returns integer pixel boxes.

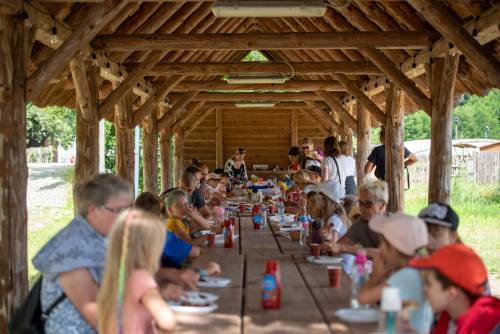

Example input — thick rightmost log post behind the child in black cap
[429,55,459,204]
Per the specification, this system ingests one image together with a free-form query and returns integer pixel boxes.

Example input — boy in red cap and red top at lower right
[410,244,500,334]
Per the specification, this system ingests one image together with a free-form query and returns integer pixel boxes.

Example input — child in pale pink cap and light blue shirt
[358,214,432,333]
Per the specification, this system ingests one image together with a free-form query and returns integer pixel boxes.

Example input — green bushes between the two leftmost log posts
[26,103,76,148]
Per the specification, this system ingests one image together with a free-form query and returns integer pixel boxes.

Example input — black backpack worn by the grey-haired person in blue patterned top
[9,277,66,334]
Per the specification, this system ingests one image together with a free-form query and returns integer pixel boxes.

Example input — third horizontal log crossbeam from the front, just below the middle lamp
[173,80,345,92]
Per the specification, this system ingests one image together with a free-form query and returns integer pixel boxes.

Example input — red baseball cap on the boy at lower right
[410,244,488,295]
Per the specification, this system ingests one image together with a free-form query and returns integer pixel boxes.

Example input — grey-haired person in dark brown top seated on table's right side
[323,180,389,258]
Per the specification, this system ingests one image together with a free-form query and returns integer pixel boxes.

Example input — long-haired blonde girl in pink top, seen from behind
[97,209,175,334]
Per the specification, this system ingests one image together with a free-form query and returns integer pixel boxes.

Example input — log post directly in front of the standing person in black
[385,83,405,212]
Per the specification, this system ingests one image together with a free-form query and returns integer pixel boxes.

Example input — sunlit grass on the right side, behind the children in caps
[405,178,500,278]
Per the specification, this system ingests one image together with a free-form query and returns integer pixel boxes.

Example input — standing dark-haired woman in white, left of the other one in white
[321,137,346,188]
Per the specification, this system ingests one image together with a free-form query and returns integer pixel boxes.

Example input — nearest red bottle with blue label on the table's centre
[262,260,281,310]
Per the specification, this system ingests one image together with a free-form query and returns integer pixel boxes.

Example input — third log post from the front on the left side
[115,93,135,185]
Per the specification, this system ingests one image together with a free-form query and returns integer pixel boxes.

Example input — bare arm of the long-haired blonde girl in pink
[141,289,175,331]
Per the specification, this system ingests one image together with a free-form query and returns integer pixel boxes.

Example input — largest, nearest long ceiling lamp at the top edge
[212,0,326,17]
